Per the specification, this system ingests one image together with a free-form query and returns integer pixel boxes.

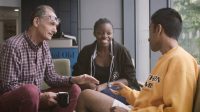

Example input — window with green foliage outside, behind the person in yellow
[170,0,200,62]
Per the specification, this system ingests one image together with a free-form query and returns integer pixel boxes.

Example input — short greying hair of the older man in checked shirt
[30,5,55,25]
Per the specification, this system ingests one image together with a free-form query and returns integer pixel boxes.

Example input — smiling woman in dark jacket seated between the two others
[73,18,140,103]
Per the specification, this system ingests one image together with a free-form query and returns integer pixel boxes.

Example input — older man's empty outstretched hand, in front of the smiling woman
[71,74,99,85]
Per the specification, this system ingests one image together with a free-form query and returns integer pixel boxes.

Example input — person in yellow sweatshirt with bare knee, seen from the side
[76,8,198,112]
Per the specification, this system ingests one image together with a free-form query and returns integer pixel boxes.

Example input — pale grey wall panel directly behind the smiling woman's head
[78,0,122,48]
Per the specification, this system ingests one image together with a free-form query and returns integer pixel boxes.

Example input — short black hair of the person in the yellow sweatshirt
[151,8,182,40]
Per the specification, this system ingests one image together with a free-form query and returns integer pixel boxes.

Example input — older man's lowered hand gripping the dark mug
[40,92,57,109]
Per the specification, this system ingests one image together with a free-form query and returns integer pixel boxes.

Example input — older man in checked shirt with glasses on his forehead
[0,5,98,112]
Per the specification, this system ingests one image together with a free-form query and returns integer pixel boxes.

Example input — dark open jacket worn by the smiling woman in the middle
[72,41,139,90]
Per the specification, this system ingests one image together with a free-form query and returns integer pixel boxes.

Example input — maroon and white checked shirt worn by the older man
[0,32,68,93]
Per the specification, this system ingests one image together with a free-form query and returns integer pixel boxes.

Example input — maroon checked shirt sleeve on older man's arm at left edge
[0,44,21,92]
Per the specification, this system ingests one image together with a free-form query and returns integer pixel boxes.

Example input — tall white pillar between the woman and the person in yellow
[135,0,150,82]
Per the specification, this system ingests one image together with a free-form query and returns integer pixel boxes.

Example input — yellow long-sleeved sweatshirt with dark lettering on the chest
[120,47,198,112]
